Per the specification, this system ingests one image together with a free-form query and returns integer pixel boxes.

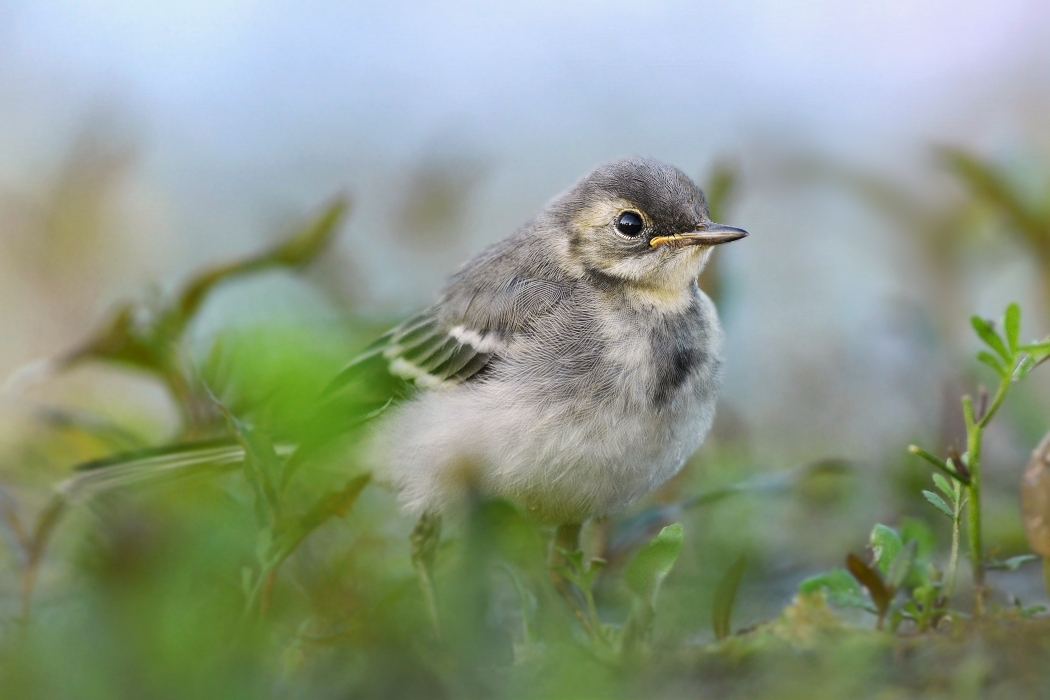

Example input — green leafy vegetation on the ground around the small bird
[0,144,1050,698]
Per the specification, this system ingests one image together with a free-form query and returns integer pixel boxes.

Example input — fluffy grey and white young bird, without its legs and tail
[369,158,747,523]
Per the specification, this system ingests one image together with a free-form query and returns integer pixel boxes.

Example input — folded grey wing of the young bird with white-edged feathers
[331,277,570,389]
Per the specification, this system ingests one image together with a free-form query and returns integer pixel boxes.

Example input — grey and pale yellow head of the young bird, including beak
[548,158,748,293]
